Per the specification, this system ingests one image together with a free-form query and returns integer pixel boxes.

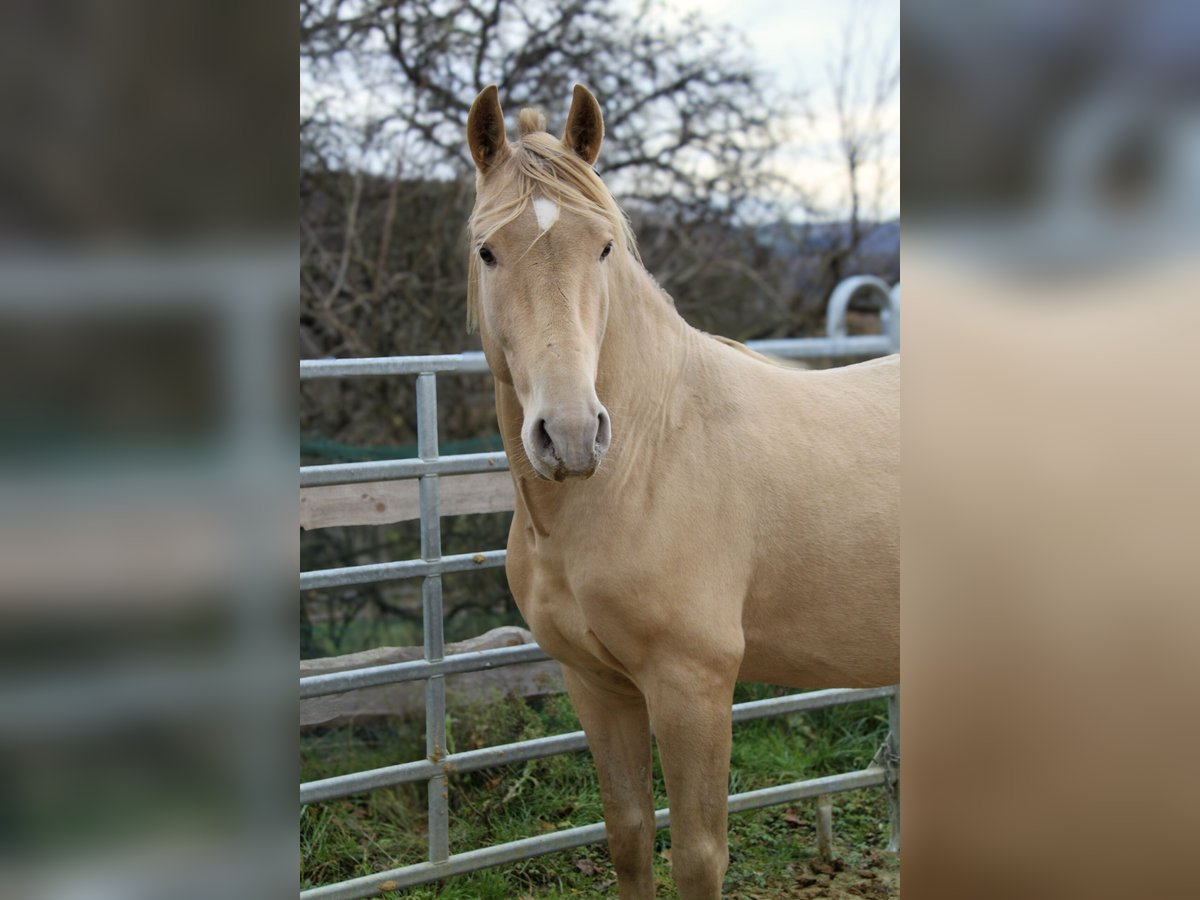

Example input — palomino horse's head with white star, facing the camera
[467,85,632,481]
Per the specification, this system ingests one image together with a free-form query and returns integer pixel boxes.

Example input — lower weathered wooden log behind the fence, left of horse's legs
[300,625,565,730]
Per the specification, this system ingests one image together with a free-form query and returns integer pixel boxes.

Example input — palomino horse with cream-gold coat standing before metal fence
[467,85,900,900]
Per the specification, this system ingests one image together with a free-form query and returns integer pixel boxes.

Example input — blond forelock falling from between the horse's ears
[467,109,641,331]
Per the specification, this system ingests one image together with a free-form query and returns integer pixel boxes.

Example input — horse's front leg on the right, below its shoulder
[642,647,740,900]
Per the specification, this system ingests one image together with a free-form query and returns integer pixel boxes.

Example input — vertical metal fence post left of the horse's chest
[416,372,450,863]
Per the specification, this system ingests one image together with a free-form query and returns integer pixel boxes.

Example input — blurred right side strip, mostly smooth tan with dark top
[902,2,1200,900]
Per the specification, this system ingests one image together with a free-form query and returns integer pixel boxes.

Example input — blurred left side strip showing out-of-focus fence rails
[0,2,298,900]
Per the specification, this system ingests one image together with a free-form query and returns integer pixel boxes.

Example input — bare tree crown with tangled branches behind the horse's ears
[301,0,774,214]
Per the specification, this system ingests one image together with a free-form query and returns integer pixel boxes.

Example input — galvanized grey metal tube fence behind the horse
[300,276,900,900]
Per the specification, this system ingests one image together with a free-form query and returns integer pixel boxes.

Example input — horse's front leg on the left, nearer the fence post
[563,666,654,900]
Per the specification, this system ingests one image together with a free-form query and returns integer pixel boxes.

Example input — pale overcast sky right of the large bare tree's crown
[668,0,900,217]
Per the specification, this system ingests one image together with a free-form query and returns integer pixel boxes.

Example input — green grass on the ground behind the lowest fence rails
[300,684,888,900]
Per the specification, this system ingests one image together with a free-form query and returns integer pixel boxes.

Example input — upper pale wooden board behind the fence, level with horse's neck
[300,472,514,530]
